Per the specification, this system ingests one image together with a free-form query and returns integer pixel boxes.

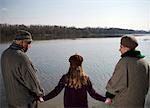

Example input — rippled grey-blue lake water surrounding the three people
[0,38,150,108]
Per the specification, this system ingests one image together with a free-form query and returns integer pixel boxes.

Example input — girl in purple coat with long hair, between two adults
[43,54,111,108]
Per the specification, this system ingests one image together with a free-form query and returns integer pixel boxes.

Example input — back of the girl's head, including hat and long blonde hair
[65,54,88,89]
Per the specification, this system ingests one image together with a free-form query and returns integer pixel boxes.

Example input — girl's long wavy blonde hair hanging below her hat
[65,64,88,89]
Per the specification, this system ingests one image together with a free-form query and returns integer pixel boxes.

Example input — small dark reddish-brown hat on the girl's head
[69,54,83,66]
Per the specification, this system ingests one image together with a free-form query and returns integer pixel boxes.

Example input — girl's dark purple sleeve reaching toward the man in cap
[43,77,65,101]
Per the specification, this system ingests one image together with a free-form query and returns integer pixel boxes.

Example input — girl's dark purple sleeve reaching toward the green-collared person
[87,78,106,102]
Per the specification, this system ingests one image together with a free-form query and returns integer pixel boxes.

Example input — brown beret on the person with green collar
[120,36,138,49]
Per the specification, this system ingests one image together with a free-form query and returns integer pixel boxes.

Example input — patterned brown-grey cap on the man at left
[15,30,32,41]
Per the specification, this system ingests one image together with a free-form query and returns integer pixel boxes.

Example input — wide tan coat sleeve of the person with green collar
[106,59,128,95]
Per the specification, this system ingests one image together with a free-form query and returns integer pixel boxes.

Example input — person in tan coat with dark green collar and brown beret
[106,36,150,108]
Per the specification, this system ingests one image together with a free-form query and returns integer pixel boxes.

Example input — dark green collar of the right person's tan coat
[121,50,145,58]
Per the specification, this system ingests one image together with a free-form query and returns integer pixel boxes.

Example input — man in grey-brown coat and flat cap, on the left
[1,30,44,108]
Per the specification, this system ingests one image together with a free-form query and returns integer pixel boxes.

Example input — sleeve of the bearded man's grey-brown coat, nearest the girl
[15,56,44,97]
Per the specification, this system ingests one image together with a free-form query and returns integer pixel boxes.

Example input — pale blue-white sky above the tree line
[0,0,150,31]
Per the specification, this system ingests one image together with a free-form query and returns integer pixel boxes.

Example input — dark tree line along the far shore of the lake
[0,24,150,42]
